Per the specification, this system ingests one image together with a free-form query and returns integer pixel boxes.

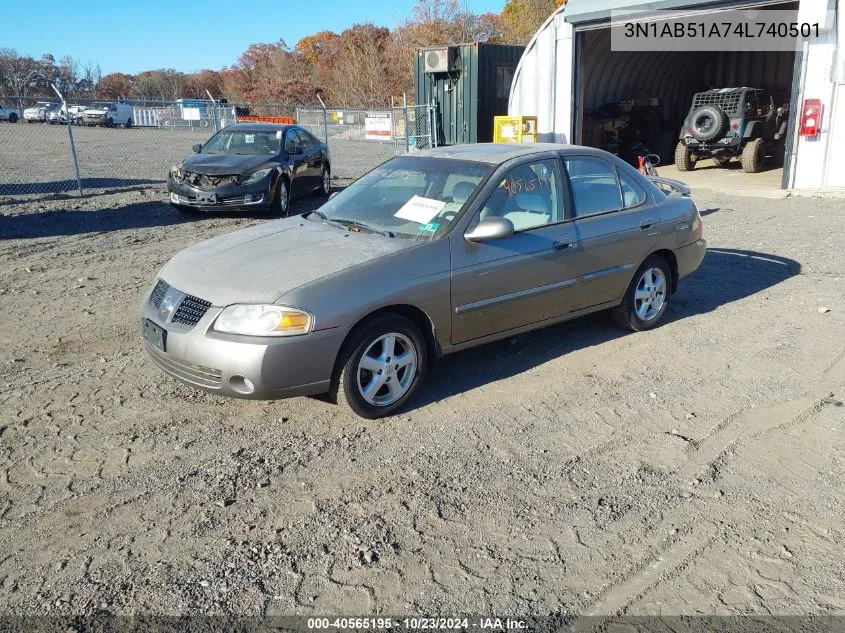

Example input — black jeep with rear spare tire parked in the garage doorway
[675,88,789,173]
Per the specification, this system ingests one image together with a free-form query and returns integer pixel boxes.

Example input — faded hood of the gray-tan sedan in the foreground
[159,217,420,308]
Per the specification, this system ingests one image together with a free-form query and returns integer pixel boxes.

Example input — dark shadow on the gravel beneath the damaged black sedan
[0,196,336,241]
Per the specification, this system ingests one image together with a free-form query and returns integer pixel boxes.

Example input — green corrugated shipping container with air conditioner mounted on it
[414,43,525,145]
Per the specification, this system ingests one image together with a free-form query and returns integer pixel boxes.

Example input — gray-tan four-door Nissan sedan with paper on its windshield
[141,144,706,418]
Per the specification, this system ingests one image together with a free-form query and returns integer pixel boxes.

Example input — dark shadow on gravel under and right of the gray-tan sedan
[416,248,801,408]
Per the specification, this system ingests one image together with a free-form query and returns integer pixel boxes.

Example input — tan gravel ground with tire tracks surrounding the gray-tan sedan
[0,184,845,615]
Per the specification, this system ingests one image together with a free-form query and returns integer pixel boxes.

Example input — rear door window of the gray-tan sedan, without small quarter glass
[563,156,622,218]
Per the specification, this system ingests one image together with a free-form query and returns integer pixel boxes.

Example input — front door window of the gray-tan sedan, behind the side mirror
[479,159,563,231]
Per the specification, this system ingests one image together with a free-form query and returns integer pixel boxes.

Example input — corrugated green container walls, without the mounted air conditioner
[414,44,524,145]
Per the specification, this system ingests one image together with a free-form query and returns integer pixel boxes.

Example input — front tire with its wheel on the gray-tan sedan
[329,314,428,420]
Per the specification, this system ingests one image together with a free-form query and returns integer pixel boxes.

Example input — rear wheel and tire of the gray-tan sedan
[611,255,673,332]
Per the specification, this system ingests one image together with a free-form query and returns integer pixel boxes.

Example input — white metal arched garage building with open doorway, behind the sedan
[508,0,845,189]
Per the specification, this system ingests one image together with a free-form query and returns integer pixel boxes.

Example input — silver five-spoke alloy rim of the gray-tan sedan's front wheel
[356,332,417,407]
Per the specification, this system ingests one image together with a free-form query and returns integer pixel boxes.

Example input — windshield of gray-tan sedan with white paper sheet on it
[317,156,493,240]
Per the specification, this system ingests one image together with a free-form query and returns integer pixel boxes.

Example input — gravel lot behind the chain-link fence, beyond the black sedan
[0,122,396,196]
